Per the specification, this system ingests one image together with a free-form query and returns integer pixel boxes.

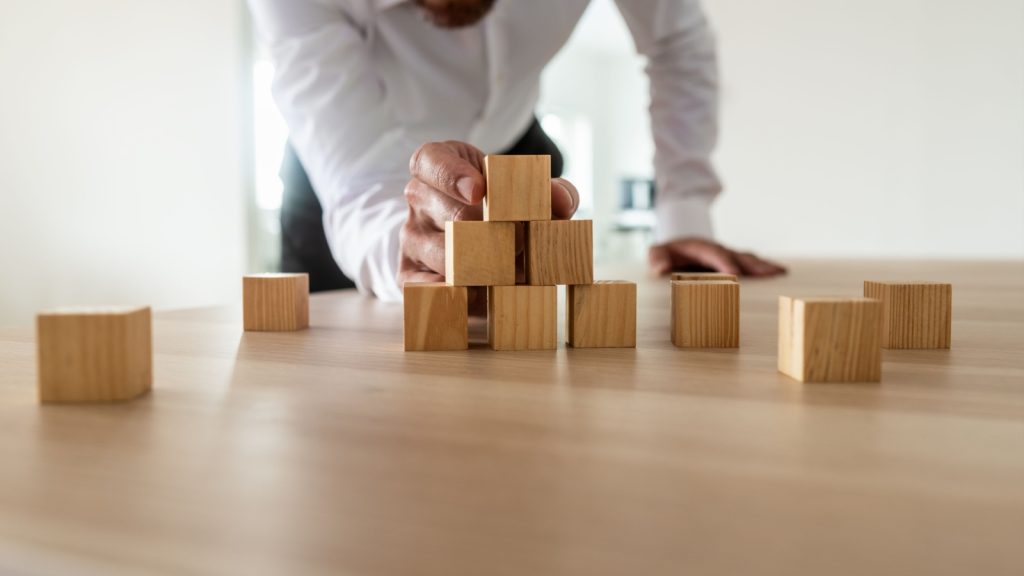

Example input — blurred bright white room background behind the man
[0,0,1024,324]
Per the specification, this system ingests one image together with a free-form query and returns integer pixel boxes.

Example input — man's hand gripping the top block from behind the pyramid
[398,140,580,312]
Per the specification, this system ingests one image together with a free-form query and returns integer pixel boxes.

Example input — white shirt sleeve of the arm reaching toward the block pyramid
[249,0,407,300]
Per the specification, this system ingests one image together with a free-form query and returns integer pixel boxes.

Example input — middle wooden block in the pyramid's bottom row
[487,286,558,349]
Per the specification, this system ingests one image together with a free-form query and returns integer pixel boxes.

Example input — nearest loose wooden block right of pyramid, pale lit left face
[778,296,882,382]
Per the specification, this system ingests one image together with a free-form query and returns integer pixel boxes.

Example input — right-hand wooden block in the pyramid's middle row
[526,220,594,286]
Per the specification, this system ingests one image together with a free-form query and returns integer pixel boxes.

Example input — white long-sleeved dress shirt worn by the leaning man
[249,0,721,300]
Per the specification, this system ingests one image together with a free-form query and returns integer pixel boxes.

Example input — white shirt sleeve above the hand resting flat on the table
[616,0,722,243]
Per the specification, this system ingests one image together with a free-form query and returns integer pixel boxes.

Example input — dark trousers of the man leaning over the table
[281,118,562,292]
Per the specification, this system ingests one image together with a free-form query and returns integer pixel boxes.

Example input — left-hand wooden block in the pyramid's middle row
[444,220,515,286]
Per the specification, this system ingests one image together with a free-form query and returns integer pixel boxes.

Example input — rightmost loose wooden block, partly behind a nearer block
[864,281,953,348]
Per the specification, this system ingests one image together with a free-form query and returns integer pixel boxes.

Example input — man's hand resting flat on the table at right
[648,238,785,278]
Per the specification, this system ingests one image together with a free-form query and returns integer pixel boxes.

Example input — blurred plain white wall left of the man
[0,0,249,324]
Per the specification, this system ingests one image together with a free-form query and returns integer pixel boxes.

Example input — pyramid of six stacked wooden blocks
[404,156,636,351]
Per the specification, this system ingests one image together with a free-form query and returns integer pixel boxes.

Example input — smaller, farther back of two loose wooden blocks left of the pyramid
[242,274,309,332]
